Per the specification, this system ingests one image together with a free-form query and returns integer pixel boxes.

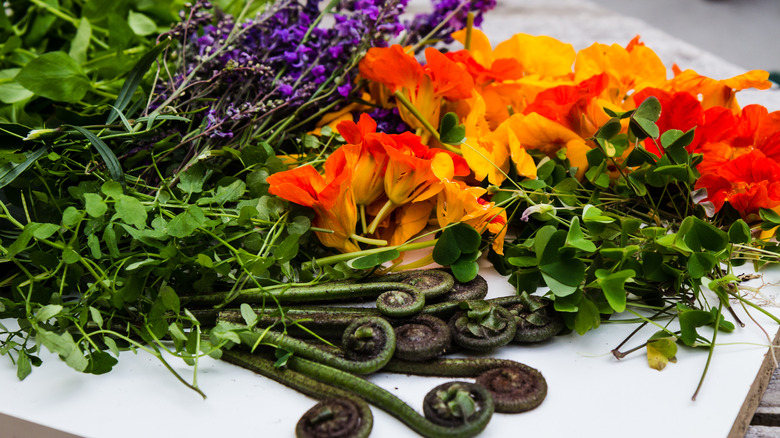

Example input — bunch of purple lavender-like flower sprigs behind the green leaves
[150,0,408,151]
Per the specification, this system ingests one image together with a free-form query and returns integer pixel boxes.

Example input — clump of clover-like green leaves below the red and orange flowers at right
[489,97,780,370]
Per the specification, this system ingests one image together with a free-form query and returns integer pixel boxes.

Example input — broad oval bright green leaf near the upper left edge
[15,52,91,103]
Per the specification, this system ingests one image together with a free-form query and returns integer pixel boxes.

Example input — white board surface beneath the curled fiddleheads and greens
[0,258,780,438]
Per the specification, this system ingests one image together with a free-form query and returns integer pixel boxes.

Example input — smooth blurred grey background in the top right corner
[588,0,780,72]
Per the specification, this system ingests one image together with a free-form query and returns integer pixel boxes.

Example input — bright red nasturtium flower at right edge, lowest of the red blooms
[695,149,780,220]
